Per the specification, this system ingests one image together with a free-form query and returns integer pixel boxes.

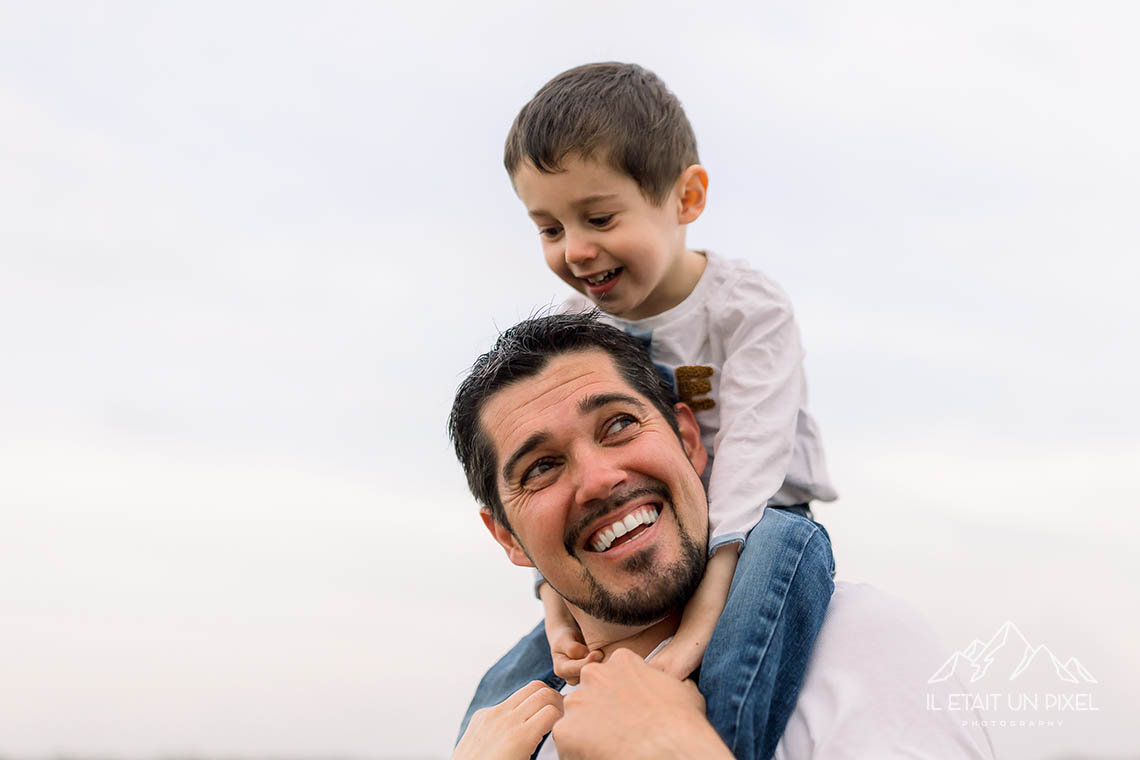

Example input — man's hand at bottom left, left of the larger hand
[451,681,562,760]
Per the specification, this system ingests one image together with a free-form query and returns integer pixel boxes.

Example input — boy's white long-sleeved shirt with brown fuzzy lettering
[563,253,837,554]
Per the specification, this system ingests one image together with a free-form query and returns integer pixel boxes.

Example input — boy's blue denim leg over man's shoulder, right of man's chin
[699,507,834,760]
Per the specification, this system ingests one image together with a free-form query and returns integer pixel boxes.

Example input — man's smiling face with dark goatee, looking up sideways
[480,350,708,624]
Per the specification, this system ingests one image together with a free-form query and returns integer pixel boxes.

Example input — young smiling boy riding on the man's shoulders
[504,63,836,746]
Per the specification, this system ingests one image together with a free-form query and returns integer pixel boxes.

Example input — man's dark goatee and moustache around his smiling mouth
[560,481,707,626]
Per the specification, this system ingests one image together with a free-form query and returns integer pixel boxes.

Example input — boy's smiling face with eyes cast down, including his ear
[513,155,703,319]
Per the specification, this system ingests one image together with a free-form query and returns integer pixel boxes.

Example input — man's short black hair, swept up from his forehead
[447,311,681,529]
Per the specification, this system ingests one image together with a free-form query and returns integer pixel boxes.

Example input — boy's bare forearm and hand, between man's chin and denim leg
[649,544,739,680]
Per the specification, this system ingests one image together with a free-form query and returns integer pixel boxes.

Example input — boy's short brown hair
[503,63,700,205]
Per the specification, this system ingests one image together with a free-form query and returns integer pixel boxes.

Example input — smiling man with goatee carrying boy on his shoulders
[449,314,992,760]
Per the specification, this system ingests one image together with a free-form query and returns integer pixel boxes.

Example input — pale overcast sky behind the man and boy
[0,0,1140,758]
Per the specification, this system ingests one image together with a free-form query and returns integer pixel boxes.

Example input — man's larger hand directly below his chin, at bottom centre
[553,649,732,760]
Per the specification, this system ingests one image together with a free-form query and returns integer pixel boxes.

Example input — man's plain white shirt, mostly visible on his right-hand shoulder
[538,581,994,760]
